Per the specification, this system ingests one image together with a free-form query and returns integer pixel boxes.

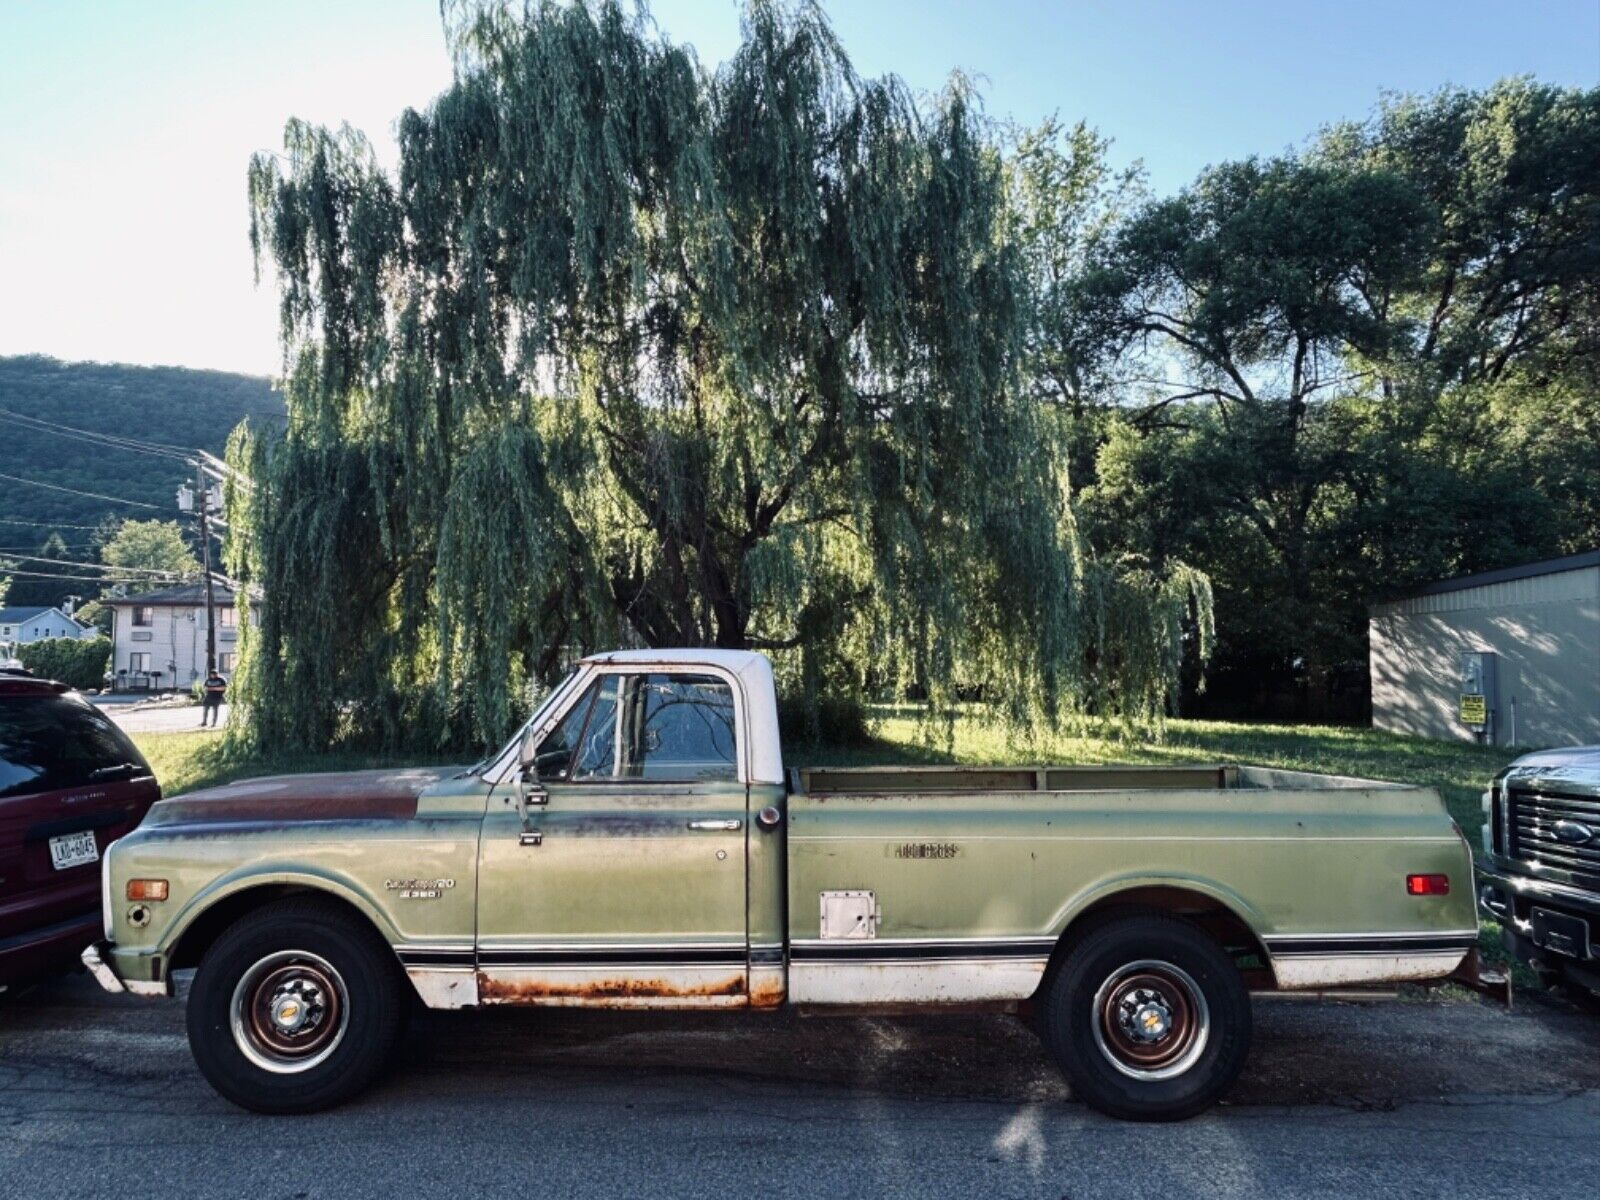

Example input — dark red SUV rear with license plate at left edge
[0,674,162,989]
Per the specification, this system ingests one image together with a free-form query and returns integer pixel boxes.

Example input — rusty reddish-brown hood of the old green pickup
[144,766,459,826]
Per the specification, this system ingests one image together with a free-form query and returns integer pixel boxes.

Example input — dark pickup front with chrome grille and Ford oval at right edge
[1477,746,1600,995]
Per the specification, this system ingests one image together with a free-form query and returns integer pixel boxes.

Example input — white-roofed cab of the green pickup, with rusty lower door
[464,650,786,1008]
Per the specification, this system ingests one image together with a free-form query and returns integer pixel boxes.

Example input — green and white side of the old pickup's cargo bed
[787,763,1477,1005]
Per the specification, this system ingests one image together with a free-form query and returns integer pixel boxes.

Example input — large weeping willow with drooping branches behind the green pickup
[232,2,1189,744]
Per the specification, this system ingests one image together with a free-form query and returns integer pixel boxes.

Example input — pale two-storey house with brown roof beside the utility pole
[102,584,256,691]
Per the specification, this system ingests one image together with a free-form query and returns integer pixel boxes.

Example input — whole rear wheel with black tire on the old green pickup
[1038,915,1251,1122]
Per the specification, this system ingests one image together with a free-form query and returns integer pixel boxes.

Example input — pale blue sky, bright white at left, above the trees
[0,0,1600,373]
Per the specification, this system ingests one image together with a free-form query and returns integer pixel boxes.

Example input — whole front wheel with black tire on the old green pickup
[187,899,406,1112]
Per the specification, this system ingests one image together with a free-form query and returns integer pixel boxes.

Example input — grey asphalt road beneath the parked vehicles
[0,976,1600,1200]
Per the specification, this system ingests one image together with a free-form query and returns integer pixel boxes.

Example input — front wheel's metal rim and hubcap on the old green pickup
[230,950,349,1075]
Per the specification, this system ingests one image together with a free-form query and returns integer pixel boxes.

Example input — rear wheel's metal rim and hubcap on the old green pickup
[1090,958,1211,1080]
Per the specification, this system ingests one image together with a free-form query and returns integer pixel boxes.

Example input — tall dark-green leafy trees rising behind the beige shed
[1062,80,1600,714]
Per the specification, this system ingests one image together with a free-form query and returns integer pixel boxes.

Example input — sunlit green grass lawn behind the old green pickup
[134,709,1514,846]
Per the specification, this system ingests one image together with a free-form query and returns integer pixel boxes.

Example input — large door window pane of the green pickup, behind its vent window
[622,675,738,781]
